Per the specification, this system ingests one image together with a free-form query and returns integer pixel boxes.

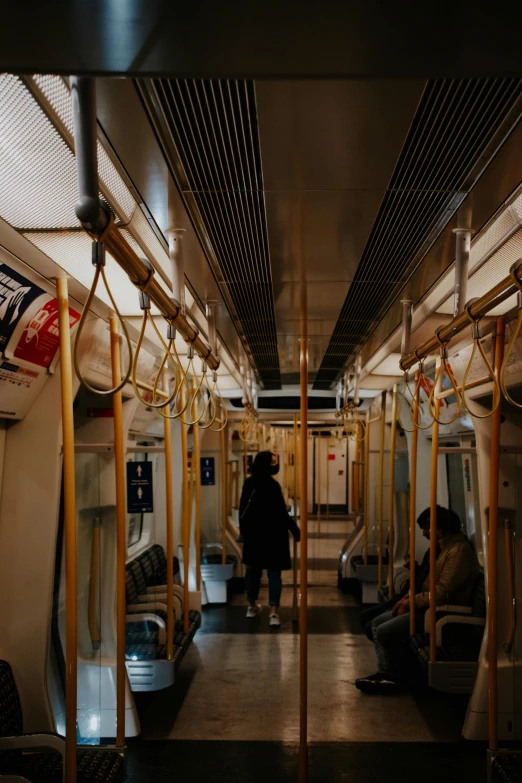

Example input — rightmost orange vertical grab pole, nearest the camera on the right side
[488,318,505,750]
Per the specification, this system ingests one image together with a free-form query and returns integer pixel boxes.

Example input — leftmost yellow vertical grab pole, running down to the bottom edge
[56,277,78,783]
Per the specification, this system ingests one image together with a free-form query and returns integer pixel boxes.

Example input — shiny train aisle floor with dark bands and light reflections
[128,519,486,783]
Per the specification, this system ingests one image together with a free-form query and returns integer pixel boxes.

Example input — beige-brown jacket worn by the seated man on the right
[415,533,479,609]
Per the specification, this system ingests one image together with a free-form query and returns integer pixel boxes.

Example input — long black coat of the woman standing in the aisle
[239,475,300,571]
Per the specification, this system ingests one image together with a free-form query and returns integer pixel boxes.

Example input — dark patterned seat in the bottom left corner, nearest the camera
[0,660,125,783]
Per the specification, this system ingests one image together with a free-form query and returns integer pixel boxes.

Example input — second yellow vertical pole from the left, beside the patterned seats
[109,315,127,748]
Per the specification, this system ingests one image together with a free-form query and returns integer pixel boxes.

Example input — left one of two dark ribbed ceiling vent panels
[140,79,281,389]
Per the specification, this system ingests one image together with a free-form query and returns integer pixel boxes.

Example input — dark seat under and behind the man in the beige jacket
[410,569,486,693]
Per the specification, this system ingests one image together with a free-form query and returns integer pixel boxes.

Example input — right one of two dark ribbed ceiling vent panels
[314,79,521,389]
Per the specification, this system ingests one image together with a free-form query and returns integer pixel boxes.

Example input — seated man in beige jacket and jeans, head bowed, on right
[355,506,479,693]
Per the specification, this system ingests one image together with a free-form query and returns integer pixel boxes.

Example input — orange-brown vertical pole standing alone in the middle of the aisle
[299,334,308,783]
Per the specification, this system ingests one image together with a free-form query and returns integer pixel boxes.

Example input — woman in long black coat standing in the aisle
[239,451,301,627]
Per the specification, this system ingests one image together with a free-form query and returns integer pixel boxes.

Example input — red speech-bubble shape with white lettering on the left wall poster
[14,299,80,368]
